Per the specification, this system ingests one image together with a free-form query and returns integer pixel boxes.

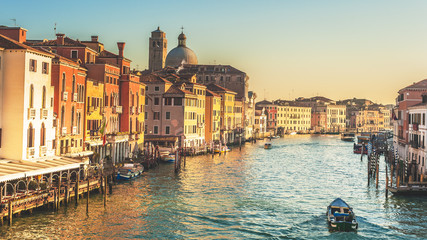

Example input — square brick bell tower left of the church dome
[148,27,168,72]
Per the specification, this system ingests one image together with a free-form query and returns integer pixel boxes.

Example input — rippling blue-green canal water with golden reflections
[0,135,427,239]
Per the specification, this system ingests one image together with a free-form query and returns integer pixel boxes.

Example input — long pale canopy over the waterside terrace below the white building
[0,157,88,183]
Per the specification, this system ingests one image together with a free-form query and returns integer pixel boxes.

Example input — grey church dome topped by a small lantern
[166,33,198,67]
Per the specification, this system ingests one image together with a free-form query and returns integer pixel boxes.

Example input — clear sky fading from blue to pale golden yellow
[0,0,427,104]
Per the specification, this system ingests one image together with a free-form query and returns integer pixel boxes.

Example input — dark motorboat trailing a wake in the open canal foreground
[326,198,359,231]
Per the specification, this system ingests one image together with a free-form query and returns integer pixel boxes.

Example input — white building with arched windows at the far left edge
[0,31,55,160]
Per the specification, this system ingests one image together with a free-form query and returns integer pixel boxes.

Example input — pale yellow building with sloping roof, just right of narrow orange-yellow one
[207,84,237,143]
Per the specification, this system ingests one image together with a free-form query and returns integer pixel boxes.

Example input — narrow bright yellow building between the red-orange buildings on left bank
[84,78,107,159]
